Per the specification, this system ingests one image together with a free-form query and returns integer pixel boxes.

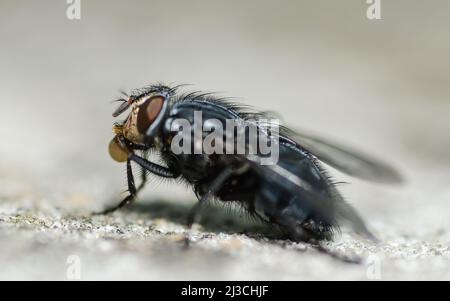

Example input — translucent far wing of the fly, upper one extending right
[283,128,403,184]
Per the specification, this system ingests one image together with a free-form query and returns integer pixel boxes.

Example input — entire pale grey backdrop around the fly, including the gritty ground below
[0,0,450,280]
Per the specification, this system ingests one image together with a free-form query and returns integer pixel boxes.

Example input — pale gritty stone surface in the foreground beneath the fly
[0,196,450,280]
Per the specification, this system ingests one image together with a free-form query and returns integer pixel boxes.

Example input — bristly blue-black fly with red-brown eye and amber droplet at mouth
[105,85,401,242]
